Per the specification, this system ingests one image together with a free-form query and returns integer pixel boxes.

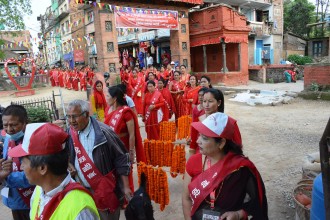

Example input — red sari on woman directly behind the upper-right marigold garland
[171,80,186,119]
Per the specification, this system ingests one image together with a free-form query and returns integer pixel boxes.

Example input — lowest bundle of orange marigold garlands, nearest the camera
[137,162,170,211]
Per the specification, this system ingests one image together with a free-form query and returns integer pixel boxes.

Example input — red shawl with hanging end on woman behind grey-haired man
[104,106,146,162]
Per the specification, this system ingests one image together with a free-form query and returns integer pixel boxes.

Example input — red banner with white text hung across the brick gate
[115,6,179,30]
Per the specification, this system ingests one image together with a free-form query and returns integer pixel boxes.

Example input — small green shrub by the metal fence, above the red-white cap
[26,106,51,123]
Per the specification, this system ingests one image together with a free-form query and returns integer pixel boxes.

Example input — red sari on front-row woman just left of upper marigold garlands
[143,91,165,140]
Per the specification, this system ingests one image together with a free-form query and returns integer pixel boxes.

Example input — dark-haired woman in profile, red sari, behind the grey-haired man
[105,86,146,192]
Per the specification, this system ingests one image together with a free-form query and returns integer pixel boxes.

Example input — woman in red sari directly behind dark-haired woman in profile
[130,69,144,115]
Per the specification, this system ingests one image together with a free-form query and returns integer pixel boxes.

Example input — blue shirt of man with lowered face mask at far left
[2,137,32,210]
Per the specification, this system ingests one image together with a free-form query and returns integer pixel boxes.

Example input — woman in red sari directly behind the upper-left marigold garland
[158,79,176,121]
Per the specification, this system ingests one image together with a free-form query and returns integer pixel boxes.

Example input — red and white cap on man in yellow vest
[8,123,69,157]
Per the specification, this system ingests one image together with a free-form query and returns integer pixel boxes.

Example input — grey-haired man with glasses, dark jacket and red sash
[66,100,132,220]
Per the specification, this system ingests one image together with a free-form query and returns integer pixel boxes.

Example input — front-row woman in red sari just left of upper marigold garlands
[142,81,165,140]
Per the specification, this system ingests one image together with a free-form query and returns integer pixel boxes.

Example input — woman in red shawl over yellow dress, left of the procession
[90,80,107,122]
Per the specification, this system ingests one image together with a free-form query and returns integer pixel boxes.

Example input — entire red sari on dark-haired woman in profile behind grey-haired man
[104,106,146,192]
